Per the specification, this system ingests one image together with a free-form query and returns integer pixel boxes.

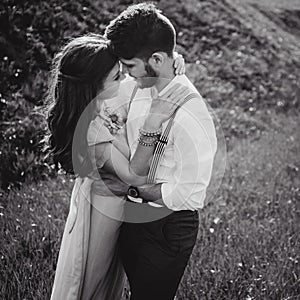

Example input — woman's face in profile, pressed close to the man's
[99,62,125,99]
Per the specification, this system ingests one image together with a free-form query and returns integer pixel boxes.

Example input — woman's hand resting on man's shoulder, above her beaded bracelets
[144,83,190,130]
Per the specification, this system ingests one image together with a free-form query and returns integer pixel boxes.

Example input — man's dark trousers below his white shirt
[120,206,199,300]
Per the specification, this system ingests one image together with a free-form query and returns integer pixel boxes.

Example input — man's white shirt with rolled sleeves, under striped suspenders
[119,75,217,211]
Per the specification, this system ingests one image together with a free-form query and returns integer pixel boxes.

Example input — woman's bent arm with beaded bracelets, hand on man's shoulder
[90,84,189,186]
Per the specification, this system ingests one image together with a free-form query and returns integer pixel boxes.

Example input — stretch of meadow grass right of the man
[178,115,300,300]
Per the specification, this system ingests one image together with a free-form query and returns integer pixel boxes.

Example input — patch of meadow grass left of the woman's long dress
[0,177,71,299]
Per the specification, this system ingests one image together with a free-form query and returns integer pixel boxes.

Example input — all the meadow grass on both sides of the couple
[0,110,300,300]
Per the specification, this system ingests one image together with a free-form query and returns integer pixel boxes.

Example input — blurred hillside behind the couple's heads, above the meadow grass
[0,0,300,187]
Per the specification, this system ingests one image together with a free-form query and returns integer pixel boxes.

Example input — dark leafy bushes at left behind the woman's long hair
[0,0,125,188]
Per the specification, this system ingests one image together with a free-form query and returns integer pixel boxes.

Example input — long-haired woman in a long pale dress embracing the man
[48,35,188,300]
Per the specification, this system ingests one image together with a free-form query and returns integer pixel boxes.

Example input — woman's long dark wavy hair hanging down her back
[46,34,118,176]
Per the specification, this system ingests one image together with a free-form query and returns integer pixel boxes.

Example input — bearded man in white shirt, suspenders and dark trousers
[105,3,216,300]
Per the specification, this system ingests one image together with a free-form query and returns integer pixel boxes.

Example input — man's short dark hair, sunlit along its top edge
[105,3,176,59]
